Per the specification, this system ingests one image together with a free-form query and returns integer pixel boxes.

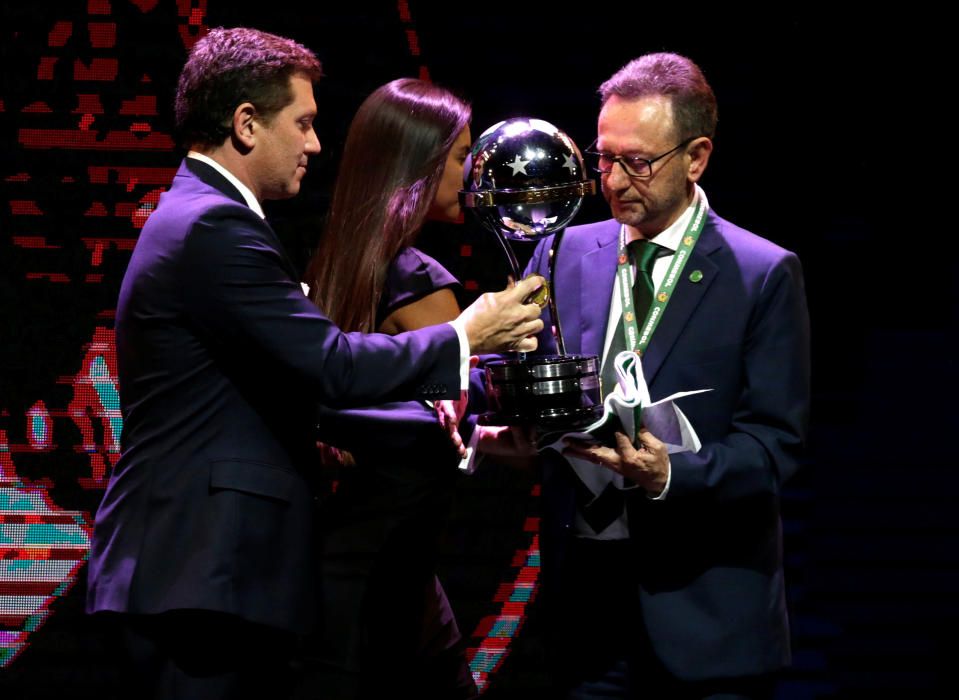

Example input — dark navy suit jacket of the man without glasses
[88,159,459,631]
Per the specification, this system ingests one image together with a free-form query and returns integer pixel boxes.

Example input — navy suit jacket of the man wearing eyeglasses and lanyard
[528,212,809,680]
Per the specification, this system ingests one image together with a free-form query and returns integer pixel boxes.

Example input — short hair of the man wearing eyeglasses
[599,53,718,139]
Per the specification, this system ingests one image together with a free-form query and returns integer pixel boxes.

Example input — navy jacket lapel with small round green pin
[643,212,722,385]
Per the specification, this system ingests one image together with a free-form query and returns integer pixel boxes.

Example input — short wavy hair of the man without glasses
[176,27,322,147]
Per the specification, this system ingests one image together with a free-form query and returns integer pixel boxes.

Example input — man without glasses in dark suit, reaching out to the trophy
[88,29,542,700]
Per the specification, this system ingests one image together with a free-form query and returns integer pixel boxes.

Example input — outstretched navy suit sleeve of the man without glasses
[182,206,460,406]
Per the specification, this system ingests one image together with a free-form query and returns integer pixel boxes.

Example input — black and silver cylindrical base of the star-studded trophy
[478,355,603,432]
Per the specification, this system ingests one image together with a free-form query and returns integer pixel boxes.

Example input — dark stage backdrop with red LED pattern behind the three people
[0,0,959,698]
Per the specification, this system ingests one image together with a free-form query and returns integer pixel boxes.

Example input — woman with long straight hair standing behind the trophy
[306,78,477,698]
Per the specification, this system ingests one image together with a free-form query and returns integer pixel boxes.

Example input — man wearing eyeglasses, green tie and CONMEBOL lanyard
[528,53,809,698]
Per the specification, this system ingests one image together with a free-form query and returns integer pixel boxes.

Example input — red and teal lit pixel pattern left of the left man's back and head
[0,0,206,668]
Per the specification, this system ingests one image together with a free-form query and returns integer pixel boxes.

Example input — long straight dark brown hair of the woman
[306,78,470,333]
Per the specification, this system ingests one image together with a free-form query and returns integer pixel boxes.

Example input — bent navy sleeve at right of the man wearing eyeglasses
[664,253,810,502]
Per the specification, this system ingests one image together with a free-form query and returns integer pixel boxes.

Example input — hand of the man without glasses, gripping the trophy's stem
[460,275,546,355]
